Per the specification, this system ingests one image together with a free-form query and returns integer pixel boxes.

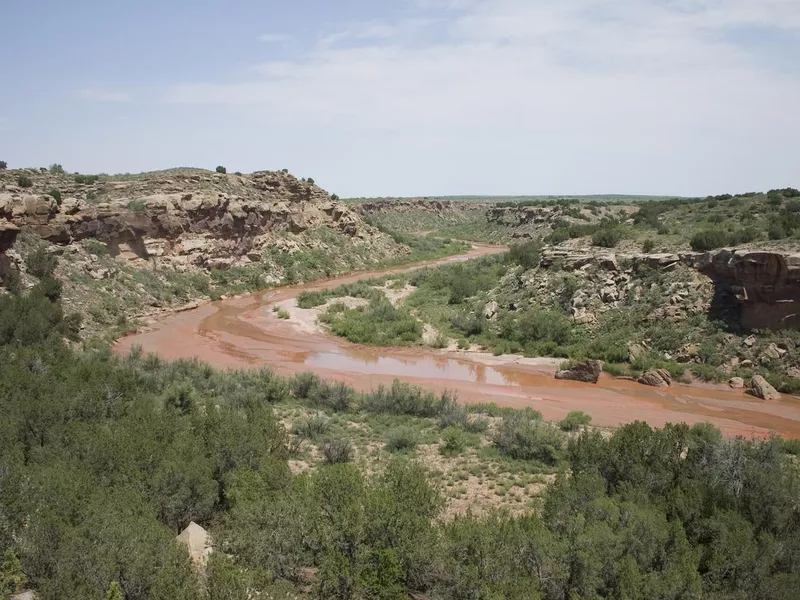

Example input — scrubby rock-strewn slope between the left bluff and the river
[6,229,469,340]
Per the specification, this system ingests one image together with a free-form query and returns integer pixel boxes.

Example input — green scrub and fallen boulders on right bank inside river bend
[310,242,800,393]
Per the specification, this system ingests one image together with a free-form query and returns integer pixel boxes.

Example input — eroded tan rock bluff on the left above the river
[0,171,397,268]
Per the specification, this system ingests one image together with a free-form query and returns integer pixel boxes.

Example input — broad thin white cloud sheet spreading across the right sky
[165,0,800,193]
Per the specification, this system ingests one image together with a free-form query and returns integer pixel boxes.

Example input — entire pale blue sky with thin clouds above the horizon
[0,0,800,197]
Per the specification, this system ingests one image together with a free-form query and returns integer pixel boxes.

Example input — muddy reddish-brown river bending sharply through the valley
[115,245,800,438]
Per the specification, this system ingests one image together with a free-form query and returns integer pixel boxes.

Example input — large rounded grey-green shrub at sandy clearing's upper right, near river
[492,414,564,466]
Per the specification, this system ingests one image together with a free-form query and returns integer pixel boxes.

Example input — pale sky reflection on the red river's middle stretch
[306,351,513,385]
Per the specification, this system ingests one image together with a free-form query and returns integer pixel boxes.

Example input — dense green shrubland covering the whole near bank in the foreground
[0,284,800,600]
